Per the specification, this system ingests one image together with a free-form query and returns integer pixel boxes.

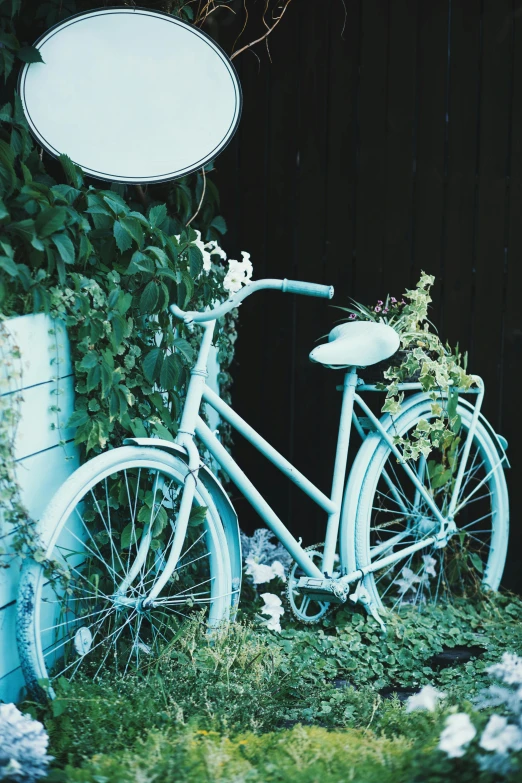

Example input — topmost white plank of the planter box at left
[0,313,73,394]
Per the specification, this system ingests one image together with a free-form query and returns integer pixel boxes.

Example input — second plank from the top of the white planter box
[8,375,74,460]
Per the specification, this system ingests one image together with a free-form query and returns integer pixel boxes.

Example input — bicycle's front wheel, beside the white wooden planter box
[17,446,232,697]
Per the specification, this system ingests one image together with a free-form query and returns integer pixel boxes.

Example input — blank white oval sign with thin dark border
[19,8,241,183]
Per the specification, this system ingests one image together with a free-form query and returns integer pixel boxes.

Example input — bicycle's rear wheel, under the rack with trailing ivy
[355,399,509,611]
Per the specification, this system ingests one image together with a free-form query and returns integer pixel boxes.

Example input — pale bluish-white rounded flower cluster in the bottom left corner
[0,704,52,783]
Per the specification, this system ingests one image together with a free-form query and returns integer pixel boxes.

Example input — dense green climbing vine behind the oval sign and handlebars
[0,0,268,556]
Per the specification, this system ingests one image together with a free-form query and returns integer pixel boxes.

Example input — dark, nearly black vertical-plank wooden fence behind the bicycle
[212,0,522,589]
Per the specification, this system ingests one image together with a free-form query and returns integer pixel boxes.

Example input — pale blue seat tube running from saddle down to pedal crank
[322,367,357,574]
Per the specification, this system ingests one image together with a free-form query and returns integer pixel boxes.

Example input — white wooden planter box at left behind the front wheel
[0,314,79,701]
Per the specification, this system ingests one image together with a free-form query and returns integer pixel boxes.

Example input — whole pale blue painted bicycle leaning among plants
[18,280,508,696]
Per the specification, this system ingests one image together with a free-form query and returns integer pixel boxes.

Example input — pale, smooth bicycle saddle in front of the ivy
[310,321,400,369]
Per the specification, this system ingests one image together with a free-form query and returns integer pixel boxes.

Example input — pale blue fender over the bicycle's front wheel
[123,438,243,616]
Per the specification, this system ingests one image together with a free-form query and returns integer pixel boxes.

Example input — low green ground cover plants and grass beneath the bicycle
[11,594,522,783]
